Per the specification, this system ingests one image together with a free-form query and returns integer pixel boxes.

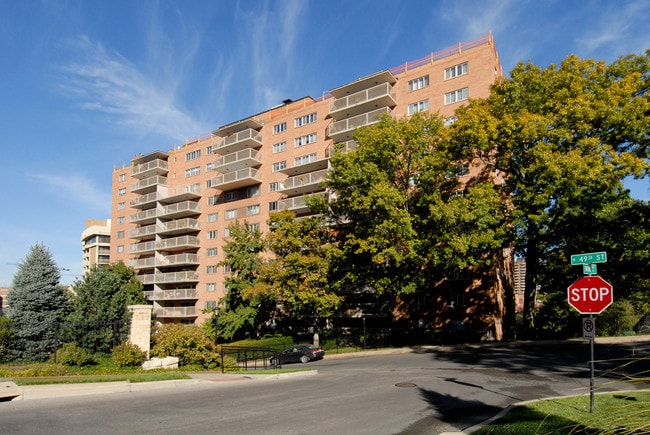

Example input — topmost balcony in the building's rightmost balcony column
[329,83,397,119]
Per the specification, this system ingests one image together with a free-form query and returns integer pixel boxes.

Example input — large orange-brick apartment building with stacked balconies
[110,34,502,324]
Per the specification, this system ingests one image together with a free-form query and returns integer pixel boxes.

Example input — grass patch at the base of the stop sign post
[472,390,650,435]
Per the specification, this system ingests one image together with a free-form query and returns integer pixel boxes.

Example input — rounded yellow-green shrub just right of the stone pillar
[151,323,219,369]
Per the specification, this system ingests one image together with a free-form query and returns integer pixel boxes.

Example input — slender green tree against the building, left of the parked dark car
[217,221,264,340]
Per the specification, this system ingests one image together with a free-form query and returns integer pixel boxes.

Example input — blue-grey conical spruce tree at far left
[7,243,68,361]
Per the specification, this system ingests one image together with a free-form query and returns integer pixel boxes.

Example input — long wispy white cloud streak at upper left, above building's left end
[60,36,203,140]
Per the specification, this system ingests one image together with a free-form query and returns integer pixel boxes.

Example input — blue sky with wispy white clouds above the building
[0,0,650,286]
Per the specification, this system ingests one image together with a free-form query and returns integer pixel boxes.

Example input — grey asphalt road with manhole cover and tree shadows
[0,342,650,434]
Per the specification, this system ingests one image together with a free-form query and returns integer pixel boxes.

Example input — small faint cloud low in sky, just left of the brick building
[27,173,111,215]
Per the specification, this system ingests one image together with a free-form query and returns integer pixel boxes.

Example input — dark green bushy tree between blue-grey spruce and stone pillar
[64,263,144,354]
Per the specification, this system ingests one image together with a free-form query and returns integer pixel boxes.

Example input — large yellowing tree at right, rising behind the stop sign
[452,52,650,336]
